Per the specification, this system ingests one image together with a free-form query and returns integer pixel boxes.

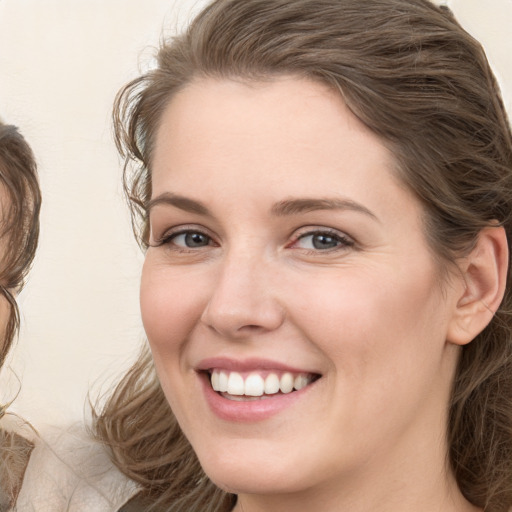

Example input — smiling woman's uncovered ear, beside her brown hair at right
[447,226,508,345]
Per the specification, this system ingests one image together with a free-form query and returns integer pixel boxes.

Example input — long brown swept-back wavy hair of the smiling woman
[96,0,512,512]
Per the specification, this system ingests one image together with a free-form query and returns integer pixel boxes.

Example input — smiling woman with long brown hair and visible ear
[97,0,512,512]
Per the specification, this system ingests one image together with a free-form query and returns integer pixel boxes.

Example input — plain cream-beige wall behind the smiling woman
[0,0,512,425]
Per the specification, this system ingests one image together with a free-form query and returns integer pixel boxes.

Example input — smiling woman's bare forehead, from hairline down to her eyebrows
[151,77,412,206]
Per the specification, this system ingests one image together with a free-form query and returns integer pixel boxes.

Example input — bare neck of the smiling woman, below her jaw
[234,428,481,512]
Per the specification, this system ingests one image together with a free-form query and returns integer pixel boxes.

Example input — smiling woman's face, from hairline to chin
[141,78,462,500]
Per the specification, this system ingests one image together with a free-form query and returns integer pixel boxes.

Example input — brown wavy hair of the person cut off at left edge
[0,121,41,367]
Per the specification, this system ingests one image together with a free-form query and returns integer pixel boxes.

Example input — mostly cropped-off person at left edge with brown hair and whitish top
[0,123,137,512]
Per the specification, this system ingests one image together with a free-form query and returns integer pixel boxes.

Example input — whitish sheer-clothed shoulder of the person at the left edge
[12,425,138,512]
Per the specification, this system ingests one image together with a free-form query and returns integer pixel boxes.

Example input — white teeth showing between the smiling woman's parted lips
[208,369,320,401]
